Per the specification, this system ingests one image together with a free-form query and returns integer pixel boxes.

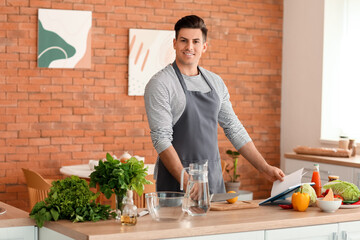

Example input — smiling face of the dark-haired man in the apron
[174,28,207,76]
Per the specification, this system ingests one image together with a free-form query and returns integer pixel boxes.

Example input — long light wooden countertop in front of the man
[45,201,360,240]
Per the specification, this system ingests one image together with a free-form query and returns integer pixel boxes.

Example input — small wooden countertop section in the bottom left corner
[0,202,35,228]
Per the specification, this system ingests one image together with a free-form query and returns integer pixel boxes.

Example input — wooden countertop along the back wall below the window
[284,153,360,168]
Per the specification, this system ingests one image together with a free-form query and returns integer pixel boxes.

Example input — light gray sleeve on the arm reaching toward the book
[219,79,252,150]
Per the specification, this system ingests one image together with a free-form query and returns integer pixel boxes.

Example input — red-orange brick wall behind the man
[0,0,283,210]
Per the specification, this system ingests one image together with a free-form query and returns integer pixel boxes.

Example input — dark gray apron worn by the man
[156,61,225,193]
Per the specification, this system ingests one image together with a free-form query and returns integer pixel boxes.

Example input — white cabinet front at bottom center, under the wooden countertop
[167,231,264,240]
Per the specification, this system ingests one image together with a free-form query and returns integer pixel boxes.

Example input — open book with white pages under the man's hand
[259,168,314,205]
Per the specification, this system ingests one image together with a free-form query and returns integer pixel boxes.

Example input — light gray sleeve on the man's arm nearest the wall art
[144,74,173,154]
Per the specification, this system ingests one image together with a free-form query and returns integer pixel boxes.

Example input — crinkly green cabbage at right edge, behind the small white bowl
[323,180,360,201]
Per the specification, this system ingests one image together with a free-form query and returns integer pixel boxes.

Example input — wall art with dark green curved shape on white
[37,9,92,68]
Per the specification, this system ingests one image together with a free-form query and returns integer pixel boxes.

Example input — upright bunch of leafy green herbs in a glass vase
[90,153,152,219]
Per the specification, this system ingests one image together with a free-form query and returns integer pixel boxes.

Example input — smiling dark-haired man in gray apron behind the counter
[144,15,285,193]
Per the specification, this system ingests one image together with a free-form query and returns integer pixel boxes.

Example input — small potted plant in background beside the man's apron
[225,150,241,192]
